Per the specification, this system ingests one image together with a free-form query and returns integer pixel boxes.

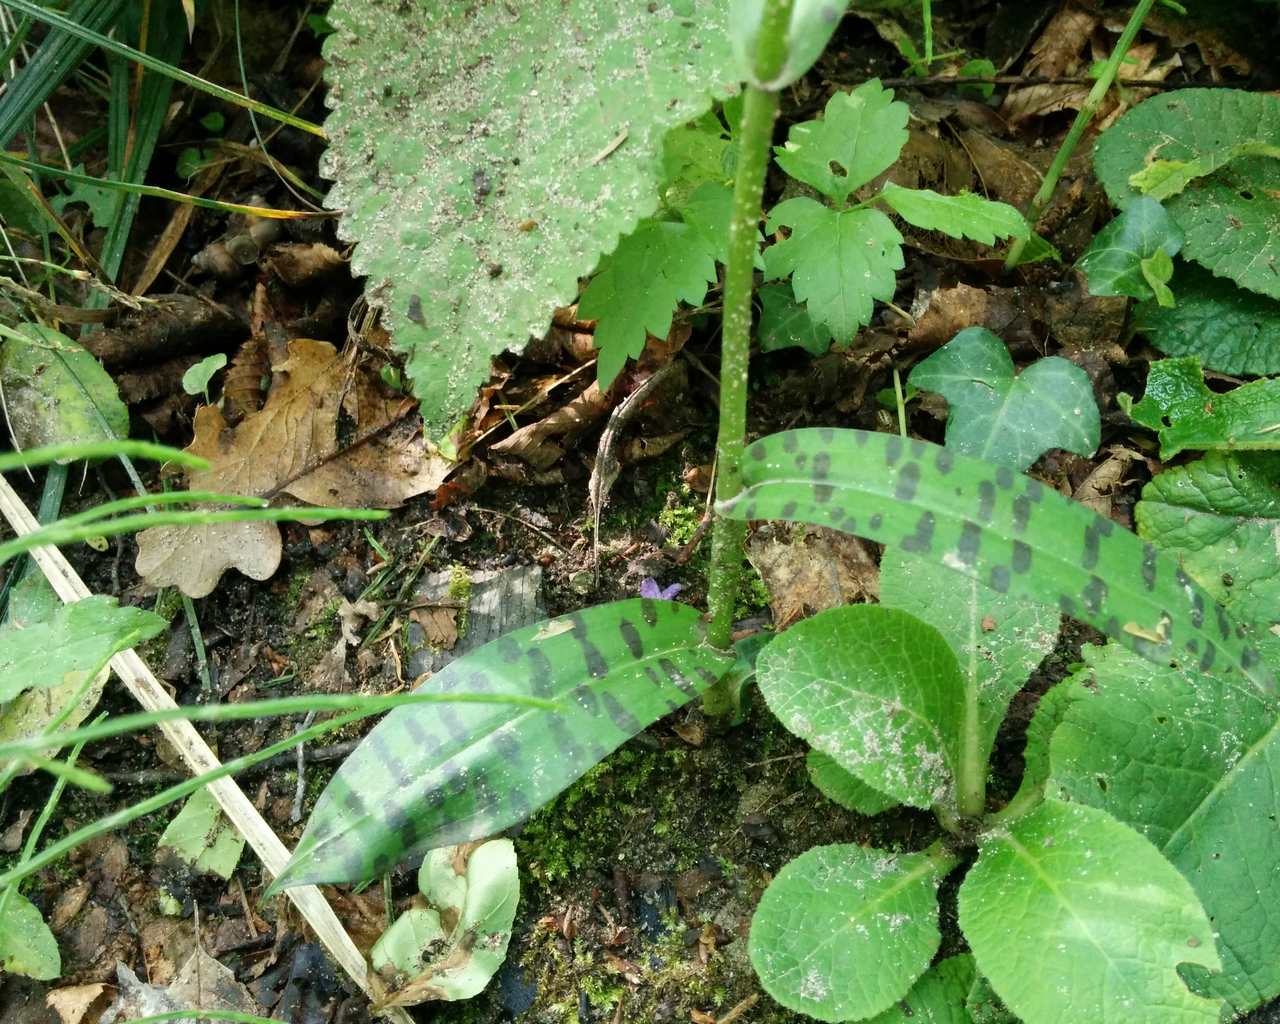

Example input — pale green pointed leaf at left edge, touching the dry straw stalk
[0,594,169,701]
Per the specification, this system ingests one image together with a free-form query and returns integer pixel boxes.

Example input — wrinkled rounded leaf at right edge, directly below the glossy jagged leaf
[1134,452,1280,631]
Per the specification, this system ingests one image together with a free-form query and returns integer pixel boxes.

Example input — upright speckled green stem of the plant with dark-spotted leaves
[703,0,792,717]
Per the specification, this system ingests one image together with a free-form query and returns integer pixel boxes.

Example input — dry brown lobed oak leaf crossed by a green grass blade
[136,338,443,598]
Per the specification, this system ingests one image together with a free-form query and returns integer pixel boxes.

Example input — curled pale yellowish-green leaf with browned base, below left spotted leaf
[369,840,520,1006]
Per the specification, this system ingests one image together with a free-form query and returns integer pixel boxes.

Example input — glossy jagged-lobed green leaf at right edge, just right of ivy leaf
[1116,356,1280,460]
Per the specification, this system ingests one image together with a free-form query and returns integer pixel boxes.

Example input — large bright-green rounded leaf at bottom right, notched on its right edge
[959,800,1221,1024]
